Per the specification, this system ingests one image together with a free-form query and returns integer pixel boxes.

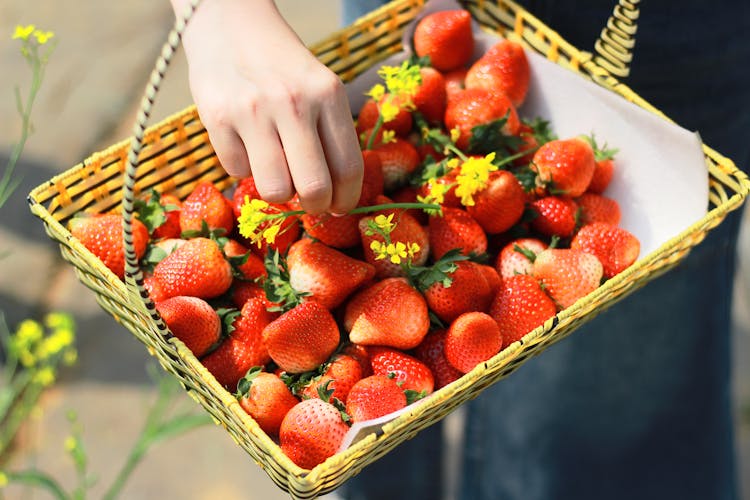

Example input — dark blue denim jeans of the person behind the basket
[341,0,750,500]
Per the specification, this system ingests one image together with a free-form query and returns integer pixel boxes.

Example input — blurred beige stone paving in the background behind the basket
[0,0,750,500]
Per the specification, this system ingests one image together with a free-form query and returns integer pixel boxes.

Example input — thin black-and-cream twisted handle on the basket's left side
[122,0,200,339]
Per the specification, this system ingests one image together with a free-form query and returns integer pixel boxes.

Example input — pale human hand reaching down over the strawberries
[172,0,363,213]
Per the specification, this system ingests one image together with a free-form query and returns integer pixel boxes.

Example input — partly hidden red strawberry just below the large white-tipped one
[370,347,435,394]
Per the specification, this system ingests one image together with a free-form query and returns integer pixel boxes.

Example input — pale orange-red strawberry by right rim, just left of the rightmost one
[534,248,603,309]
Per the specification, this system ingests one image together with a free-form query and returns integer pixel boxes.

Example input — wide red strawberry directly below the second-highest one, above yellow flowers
[445,88,521,149]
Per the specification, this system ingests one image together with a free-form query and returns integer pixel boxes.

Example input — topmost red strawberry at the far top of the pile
[414,9,474,71]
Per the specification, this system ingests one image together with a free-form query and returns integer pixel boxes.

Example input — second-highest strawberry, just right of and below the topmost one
[466,40,531,107]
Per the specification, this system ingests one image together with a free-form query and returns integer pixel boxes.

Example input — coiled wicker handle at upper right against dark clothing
[594,0,640,78]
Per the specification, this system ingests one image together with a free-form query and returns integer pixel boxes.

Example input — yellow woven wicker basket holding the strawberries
[28,0,750,498]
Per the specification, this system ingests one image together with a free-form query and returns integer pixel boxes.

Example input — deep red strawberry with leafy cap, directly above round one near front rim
[424,261,492,323]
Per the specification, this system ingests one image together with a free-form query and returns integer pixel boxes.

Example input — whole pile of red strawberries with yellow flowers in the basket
[69,10,640,468]
